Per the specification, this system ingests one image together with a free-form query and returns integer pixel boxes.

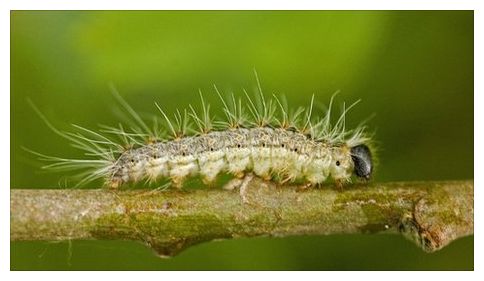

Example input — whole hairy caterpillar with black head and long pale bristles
[32,76,373,191]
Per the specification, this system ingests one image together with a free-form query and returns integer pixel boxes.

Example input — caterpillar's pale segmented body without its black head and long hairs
[108,127,353,187]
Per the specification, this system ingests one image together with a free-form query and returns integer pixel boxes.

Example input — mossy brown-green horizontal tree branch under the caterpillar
[10,179,474,256]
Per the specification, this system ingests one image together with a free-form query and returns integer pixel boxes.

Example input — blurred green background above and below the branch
[10,11,474,270]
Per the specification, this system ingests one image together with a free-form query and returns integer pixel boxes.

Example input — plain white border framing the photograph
[0,0,484,280]
